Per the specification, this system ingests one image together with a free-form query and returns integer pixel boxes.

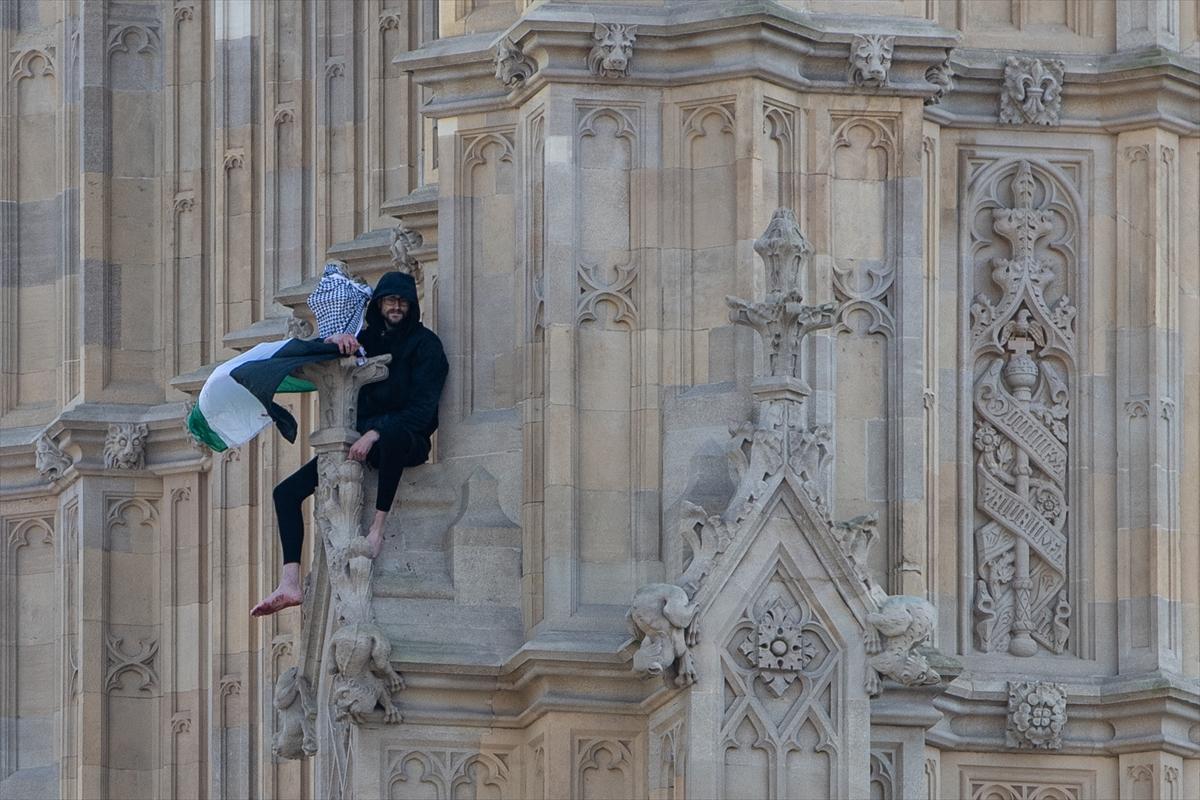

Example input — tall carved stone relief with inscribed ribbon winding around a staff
[971,161,1075,656]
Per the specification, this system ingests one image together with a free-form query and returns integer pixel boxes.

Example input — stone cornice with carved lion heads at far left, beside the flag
[0,403,210,500]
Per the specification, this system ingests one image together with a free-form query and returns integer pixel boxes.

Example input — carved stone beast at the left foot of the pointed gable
[625,583,700,687]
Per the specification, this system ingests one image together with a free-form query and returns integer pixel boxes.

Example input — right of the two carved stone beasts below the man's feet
[329,622,404,724]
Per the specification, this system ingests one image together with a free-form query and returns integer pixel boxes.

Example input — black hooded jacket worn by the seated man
[358,272,450,453]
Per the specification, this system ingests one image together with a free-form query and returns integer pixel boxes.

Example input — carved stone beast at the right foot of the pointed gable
[864,584,942,697]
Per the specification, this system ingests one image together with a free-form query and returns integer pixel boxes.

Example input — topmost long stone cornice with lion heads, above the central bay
[394,0,958,116]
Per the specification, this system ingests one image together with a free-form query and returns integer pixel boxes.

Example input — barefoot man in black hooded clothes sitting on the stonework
[250,272,449,616]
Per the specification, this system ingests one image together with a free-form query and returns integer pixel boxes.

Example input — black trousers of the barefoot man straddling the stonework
[271,434,430,564]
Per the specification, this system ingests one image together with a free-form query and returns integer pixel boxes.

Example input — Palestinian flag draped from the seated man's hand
[187,338,340,452]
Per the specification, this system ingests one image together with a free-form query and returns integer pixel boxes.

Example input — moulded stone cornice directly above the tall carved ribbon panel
[925,49,1200,136]
